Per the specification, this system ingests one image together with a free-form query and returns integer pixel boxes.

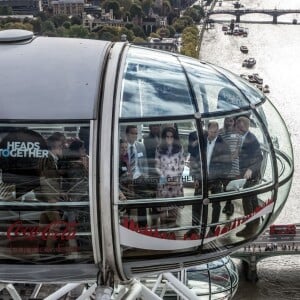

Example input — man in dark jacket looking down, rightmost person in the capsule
[236,116,263,237]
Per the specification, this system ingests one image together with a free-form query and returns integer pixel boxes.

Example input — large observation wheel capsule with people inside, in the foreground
[0,30,293,282]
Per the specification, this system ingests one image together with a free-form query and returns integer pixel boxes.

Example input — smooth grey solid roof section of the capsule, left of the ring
[0,31,111,120]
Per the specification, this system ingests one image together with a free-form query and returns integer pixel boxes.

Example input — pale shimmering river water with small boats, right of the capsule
[200,0,300,300]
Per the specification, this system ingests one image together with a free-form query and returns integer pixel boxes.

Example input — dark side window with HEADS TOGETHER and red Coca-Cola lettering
[0,123,93,264]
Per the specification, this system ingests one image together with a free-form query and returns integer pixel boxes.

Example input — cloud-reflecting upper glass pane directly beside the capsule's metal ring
[120,47,195,118]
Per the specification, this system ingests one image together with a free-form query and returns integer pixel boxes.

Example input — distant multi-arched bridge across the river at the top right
[207,8,300,24]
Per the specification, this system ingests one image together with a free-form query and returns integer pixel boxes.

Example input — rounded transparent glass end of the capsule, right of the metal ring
[114,48,293,274]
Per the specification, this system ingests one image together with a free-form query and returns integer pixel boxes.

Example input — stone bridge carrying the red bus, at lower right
[230,224,300,282]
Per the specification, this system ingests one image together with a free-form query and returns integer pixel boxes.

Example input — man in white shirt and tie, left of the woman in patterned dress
[126,125,148,227]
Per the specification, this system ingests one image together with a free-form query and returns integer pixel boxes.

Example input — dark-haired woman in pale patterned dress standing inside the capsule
[155,127,184,225]
